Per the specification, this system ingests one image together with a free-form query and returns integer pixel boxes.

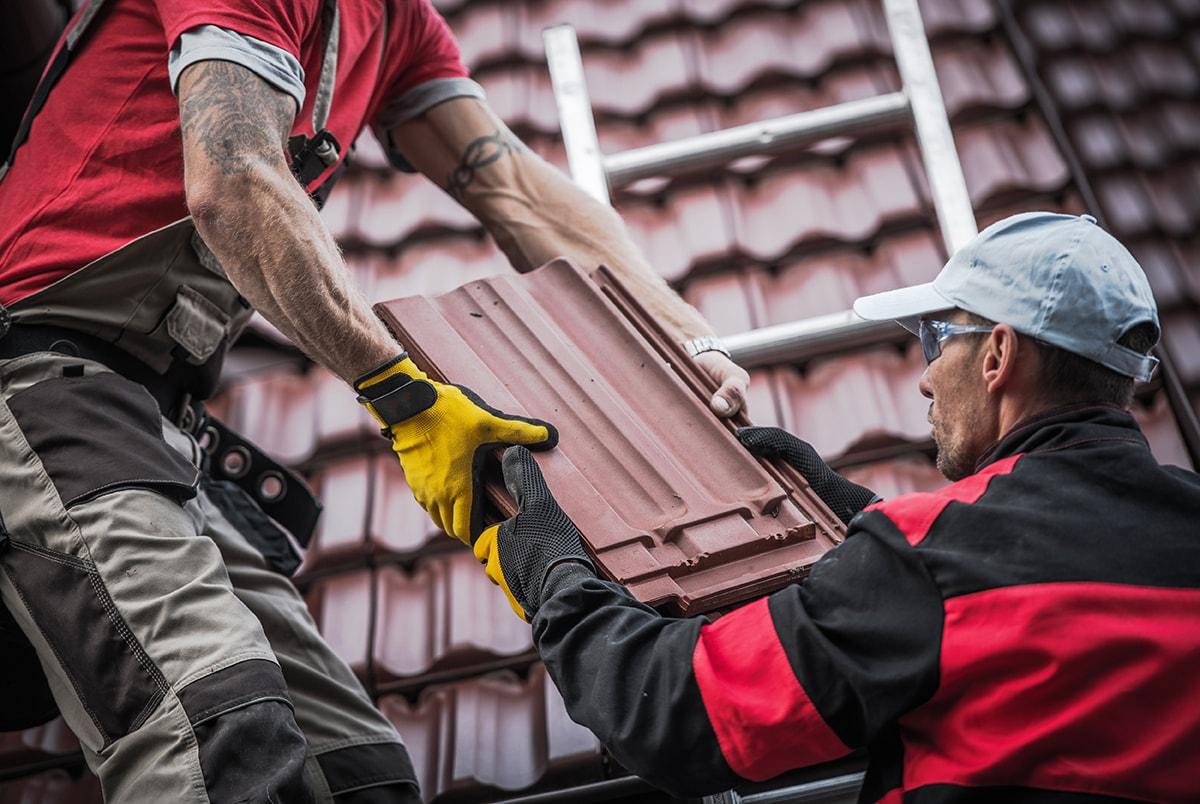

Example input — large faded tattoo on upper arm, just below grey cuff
[179,61,295,176]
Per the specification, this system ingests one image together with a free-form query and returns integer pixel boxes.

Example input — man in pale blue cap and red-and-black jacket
[475,212,1200,803]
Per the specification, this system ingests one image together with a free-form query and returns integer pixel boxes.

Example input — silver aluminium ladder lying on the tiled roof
[542,0,978,367]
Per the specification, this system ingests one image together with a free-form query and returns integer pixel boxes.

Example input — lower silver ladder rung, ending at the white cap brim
[721,310,901,368]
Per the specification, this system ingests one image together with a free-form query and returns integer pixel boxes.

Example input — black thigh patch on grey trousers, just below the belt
[8,372,199,508]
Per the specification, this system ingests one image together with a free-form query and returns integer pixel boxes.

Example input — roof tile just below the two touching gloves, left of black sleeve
[374,556,533,685]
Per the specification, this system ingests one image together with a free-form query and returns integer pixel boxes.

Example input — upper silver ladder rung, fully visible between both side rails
[604,92,911,187]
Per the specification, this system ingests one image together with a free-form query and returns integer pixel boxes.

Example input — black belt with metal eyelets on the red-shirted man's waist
[0,324,322,547]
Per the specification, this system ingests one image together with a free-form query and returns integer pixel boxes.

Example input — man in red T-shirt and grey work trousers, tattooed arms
[0,0,748,804]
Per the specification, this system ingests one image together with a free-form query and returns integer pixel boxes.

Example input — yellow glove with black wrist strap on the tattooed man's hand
[354,353,558,546]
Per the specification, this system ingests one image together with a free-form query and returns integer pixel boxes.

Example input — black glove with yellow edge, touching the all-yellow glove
[474,446,595,620]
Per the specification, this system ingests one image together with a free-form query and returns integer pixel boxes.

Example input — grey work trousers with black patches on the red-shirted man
[0,353,420,804]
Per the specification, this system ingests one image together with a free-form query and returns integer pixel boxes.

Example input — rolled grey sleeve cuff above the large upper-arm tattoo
[167,25,305,112]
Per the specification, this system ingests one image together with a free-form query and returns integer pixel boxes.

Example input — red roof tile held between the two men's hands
[378,262,836,611]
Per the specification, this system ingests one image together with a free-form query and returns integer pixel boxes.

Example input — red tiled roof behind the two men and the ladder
[0,0,1200,804]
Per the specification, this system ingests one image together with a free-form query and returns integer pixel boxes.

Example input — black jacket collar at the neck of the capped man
[976,403,1150,472]
